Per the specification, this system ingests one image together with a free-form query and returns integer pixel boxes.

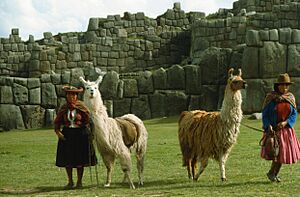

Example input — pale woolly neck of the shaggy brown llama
[220,86,243,123]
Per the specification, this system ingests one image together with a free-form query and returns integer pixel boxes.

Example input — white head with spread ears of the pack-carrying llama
[79,72,105,99]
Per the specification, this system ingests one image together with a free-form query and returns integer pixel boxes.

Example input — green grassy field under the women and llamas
[0,117,300,197]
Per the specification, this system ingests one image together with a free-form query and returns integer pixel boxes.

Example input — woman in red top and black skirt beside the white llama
[54,86,96,189]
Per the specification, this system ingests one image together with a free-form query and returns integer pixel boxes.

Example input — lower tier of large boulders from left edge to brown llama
[0,64,216,130]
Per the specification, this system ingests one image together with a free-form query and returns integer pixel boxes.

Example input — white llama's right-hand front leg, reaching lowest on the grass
[119,150,135,189]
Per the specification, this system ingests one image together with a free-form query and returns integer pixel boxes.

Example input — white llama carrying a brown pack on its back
[80,72,148,189]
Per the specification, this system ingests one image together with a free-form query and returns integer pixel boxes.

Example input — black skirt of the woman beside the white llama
[56,128,97,168]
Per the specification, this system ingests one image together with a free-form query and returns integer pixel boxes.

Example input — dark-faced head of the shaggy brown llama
[227,68,247,91]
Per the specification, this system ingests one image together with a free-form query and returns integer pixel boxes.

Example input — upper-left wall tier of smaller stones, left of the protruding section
[0,3,205,77]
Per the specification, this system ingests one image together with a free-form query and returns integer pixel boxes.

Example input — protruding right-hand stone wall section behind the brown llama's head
[191,0,300,116]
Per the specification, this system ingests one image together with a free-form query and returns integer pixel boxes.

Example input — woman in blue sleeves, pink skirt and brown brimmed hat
[261,73,300,182]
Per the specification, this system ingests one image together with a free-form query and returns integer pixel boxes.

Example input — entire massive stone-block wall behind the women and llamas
[0,0,300,130]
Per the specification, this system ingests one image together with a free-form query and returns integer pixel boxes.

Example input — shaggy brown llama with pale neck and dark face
[178,69,246,181]
